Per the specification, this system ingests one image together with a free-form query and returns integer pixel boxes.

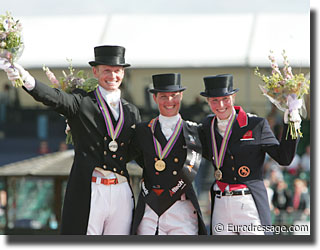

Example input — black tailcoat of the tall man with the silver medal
[27,81,140,234]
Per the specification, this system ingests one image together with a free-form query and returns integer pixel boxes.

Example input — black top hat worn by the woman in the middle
[149,73,186,93]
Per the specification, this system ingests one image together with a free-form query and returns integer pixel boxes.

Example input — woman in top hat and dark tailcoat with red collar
[199,74,297,235]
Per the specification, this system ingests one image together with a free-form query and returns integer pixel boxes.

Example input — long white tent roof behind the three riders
[19,13,310,68]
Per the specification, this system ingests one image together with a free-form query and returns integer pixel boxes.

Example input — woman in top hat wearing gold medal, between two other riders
[131,73,206,235]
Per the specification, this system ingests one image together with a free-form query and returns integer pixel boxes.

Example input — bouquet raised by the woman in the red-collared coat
[254,50,310,139]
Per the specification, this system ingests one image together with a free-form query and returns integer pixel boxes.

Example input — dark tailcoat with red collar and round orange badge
[199,106,297,234]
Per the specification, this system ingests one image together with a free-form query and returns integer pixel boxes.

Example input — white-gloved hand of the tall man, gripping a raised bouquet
[0,59,35,90]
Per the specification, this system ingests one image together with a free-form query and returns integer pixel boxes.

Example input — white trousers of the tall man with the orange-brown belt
[87,182,134,235]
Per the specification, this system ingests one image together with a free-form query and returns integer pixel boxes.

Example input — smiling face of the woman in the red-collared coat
[207,94,235,120]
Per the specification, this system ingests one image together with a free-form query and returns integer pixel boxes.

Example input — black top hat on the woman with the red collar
[200,74,239,97]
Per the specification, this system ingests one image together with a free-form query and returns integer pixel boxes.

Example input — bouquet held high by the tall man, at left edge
[0,12,24,87]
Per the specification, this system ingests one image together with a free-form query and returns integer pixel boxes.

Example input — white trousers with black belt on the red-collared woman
[212,194,264,235]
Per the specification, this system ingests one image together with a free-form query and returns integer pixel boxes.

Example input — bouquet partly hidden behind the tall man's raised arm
[43,59,98,144]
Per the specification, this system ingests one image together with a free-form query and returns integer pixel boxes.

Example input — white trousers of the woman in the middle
[137,200,198,235]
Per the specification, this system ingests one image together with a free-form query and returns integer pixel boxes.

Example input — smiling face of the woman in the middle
[153,92,183,117]
